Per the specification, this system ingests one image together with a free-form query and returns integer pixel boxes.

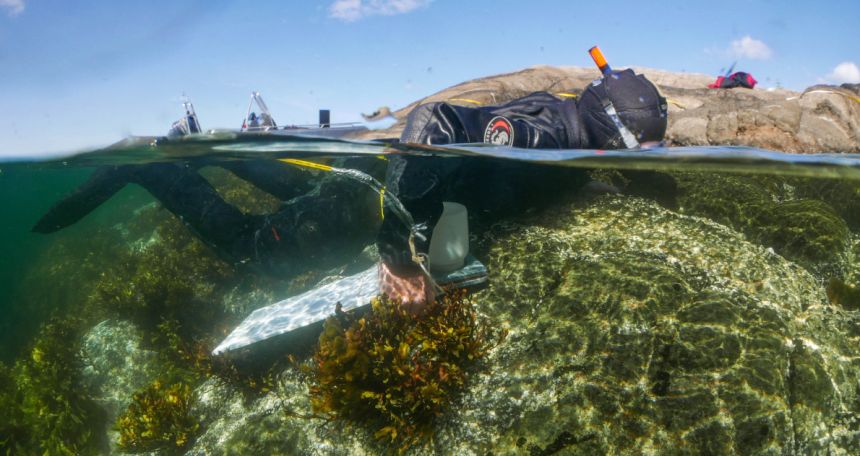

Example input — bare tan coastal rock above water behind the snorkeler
[360,66,860,153]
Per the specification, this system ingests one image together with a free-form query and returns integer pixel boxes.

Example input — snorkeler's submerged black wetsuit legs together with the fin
[33,159,381,277]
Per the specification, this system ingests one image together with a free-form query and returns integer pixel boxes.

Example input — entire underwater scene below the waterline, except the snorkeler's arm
[0,134,860,455]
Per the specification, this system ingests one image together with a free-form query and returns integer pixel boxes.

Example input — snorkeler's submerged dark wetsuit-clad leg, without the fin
[134,164,379,276]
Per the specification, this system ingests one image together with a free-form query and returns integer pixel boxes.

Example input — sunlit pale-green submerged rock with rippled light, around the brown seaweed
[181,195,860,455]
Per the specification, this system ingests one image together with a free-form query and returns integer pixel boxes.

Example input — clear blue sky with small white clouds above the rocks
[0,0,860,158]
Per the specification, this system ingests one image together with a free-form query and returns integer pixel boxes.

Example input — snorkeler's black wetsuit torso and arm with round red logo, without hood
[377,92,587,274]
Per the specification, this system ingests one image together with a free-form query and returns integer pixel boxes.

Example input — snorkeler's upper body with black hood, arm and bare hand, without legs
[377,62,668,309]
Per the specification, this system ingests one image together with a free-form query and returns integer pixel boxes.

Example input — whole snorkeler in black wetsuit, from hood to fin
[33,52,667,303]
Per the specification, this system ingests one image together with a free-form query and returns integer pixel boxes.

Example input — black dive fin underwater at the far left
[33,166,130,233]
